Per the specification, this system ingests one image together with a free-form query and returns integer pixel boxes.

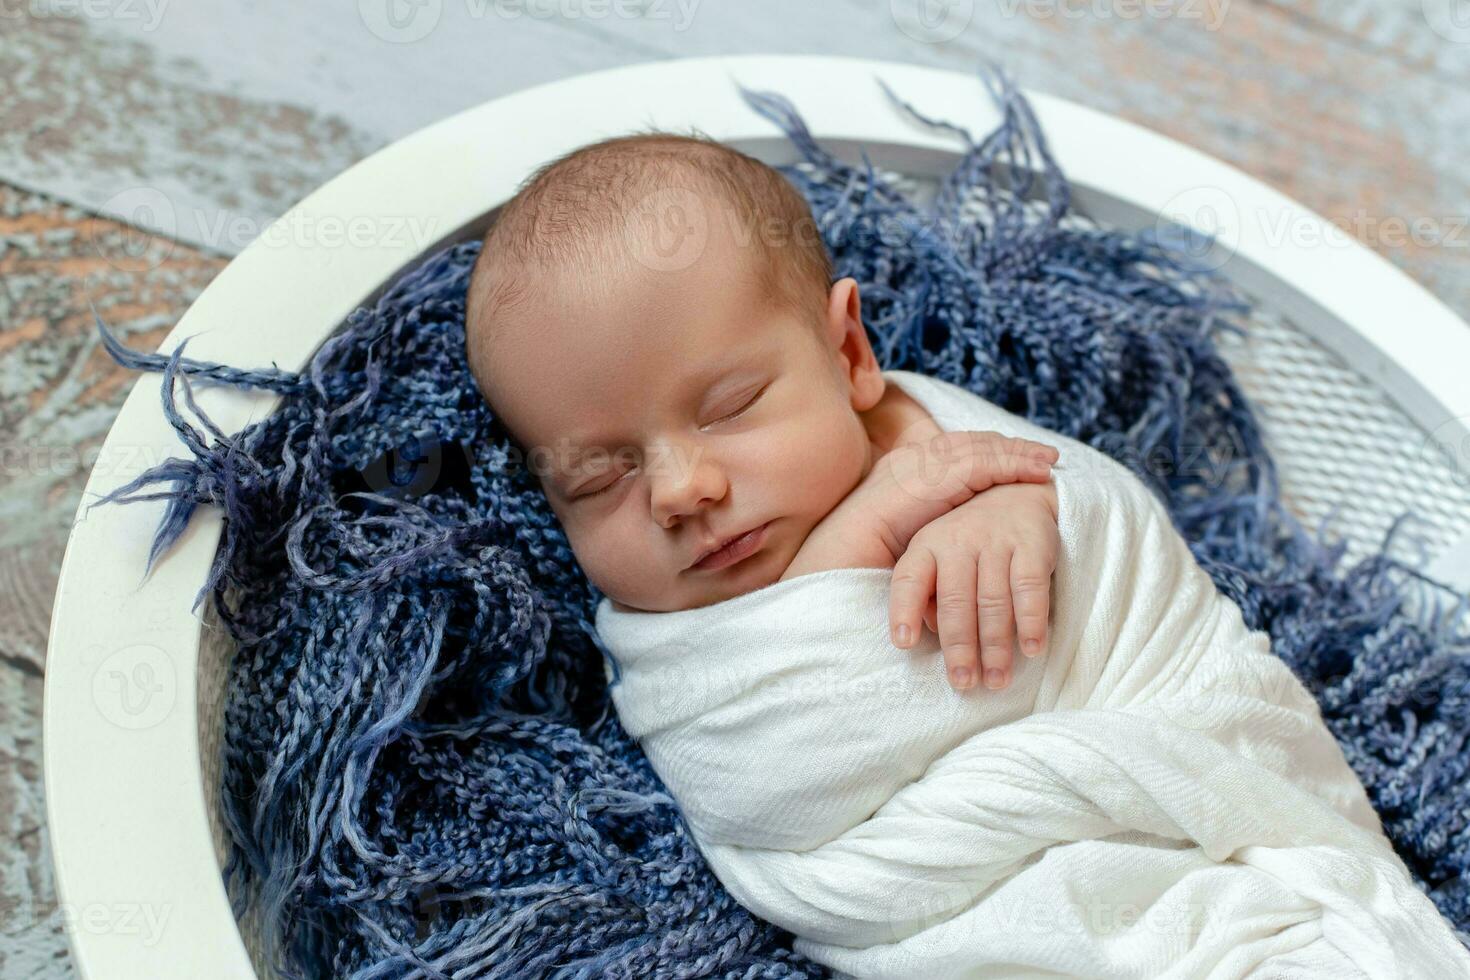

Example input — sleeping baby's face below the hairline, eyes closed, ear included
[476,220,882,611]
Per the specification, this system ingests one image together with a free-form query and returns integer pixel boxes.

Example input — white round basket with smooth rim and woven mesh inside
[44,56,1470,980]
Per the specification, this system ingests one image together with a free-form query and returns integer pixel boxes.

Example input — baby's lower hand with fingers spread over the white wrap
[888,483,1061,691]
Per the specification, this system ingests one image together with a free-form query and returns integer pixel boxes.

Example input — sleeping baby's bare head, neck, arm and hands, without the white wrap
[466,130,1057,689]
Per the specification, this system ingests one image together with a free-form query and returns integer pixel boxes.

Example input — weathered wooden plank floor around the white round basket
[0,0,1470,979]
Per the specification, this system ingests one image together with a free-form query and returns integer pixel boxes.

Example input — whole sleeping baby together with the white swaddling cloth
[466,134,1470,979]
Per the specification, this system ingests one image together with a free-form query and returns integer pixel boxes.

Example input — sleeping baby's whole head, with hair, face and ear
[465,134,885,611]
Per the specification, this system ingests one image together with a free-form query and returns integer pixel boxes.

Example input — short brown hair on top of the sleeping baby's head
[465,129,833,405]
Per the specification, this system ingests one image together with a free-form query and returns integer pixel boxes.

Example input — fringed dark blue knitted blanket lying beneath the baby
[93,75,1470,980]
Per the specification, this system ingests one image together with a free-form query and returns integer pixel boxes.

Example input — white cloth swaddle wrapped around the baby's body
[597,370,1470,980]
